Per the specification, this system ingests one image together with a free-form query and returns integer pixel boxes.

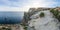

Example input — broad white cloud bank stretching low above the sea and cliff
[0,0,57,11]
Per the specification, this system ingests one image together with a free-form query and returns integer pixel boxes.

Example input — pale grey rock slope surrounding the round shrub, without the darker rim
[28,10,59,30]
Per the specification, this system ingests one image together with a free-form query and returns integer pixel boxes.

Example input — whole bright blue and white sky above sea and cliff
[0,0,60,12]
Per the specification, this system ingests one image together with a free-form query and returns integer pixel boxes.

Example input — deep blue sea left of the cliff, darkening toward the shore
[0,12,24,24]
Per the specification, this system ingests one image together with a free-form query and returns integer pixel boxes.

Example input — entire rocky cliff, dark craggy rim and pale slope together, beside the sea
[24,8,60,30]
